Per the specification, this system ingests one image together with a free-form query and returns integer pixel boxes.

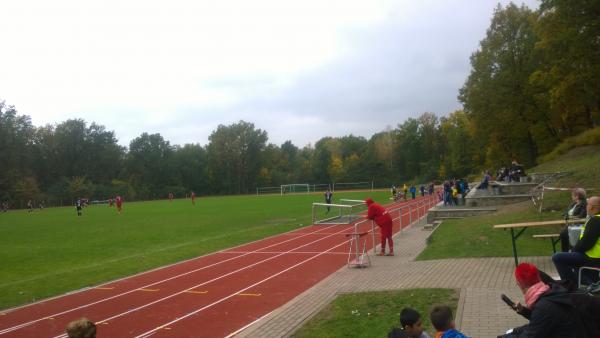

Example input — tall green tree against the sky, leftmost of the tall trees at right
[459,3,541,166]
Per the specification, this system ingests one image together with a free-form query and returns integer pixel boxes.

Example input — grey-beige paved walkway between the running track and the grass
[236,215,557,338]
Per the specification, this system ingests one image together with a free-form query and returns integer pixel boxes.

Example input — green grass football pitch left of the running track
[0,191,389,309]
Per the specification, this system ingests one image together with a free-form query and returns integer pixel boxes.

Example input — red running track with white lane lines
[0,196,437,338]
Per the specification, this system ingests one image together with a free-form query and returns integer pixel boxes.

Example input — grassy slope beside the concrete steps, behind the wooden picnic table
[418,145,600,259]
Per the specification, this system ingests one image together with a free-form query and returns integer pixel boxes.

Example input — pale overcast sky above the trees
[0,0,538,147]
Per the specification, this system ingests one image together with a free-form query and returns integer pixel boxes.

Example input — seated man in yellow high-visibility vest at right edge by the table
[552,196,600,285]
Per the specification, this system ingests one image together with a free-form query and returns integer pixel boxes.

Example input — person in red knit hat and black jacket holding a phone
[498,263,580,338]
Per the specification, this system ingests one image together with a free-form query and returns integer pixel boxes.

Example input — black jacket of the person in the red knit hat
[500,284,579,338]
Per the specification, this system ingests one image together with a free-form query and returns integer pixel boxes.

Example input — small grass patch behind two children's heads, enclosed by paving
[294,289,459,338]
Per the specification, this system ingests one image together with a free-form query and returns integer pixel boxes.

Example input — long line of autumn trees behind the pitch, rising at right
[0,0,600,205]
